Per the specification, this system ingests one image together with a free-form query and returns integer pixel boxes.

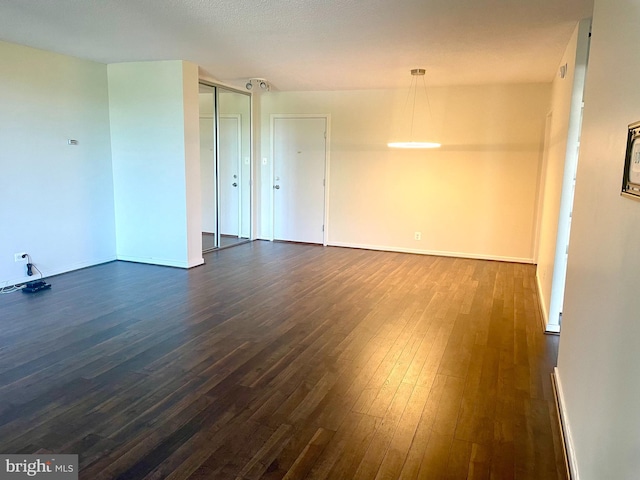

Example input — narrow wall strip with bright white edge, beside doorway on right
[536,19,591,331]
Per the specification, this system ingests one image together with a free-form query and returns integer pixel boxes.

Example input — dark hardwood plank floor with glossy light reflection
[0,242,565,480]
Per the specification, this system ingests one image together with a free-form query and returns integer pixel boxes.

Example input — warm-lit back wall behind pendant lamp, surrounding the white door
[254,84,550,262]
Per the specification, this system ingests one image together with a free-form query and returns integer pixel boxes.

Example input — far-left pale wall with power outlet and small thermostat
[0,42,115,286]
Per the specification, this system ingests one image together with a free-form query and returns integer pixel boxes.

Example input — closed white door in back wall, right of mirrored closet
[273,117,327,243]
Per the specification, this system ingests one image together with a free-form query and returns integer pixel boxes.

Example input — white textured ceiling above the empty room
[0,0,593,90]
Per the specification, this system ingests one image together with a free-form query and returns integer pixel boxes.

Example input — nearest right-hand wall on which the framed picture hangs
[558,0,640,480]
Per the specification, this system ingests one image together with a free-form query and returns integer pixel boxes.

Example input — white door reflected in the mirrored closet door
[218,115,241,237]
